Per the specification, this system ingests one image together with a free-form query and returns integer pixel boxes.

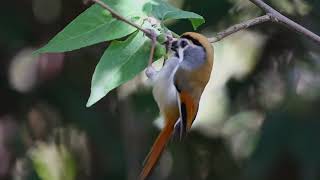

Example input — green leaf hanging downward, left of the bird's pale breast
[87,32,151,107]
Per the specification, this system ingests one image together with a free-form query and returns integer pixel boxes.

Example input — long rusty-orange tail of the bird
[140,123,174,180]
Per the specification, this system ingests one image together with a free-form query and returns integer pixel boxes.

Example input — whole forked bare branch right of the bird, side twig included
[209,0,320,44]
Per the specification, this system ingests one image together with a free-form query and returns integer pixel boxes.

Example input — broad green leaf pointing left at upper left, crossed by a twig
[36,0,149,53]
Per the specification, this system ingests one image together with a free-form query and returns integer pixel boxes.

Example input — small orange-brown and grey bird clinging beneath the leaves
[140,32,213,180]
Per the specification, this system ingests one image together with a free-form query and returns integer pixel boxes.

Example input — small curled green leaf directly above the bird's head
[151,0,205,29]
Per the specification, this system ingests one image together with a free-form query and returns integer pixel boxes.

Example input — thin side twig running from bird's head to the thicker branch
[208,14,270,43]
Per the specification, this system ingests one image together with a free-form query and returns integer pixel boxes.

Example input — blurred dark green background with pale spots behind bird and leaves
[0,0,320,180]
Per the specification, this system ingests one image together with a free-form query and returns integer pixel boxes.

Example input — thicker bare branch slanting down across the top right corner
[250,0,320,44]
